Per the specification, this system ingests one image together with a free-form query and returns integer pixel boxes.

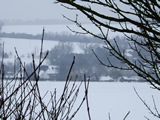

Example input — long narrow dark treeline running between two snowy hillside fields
[0,32,100,43]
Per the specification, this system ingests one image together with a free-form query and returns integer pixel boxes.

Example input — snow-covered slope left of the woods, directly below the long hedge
[0,38,59,56]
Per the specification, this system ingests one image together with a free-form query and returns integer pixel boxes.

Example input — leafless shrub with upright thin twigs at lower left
[0,30,88,120]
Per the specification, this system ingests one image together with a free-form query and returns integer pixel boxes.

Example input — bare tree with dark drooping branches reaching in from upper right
[57,0,160,117]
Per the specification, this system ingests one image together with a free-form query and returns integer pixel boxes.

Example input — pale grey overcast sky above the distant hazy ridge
[0,0,79,20]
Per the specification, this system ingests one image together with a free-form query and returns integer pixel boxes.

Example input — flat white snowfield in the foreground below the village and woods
[39,81,160,120]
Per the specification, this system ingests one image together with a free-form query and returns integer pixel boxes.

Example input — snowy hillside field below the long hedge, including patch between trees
[0,38,83,63]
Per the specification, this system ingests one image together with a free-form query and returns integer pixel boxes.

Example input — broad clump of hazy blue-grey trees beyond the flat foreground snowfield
[43,38,138,81]
